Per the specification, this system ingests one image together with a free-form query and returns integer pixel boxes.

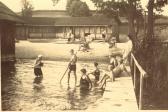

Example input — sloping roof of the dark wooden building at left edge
[0,2,24,23]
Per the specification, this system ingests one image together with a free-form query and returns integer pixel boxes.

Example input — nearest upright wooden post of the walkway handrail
[139,74,144,110]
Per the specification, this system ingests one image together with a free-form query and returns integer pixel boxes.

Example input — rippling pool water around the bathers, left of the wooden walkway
[1,59,107,111]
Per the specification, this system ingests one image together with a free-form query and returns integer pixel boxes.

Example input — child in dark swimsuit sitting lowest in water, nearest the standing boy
[80,68,92,90]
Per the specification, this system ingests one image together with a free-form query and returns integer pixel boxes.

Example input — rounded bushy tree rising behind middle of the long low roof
[67,0,91,17]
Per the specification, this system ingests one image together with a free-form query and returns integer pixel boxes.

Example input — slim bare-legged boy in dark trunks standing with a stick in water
[68,49,77,85]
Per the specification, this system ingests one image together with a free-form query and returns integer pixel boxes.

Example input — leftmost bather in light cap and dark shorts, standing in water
[34,55,43,77]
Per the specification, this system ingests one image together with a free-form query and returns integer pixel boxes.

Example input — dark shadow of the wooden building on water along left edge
[1,62,19,110]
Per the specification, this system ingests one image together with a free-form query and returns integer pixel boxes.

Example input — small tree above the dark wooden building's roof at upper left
[21,0,34,17]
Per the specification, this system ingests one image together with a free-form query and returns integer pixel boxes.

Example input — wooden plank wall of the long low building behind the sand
[17,26,114,39]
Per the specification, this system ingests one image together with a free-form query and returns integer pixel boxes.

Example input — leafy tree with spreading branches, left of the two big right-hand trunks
[92,0,143,48]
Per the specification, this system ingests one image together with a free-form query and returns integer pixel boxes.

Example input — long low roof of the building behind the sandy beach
[25,16,117,26]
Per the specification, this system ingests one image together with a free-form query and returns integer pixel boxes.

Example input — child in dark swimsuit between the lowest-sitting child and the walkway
[89,62,100,83]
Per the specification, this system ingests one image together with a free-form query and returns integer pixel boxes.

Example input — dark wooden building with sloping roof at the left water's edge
[0,2,23,61]
